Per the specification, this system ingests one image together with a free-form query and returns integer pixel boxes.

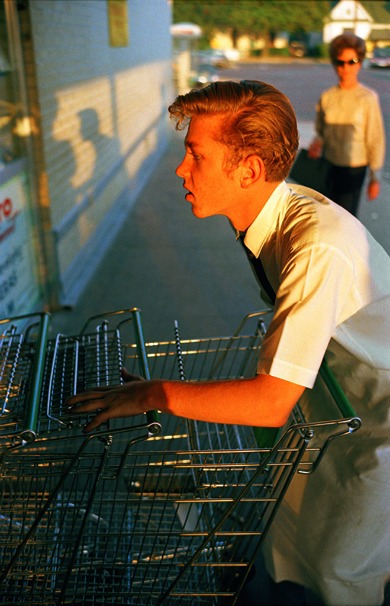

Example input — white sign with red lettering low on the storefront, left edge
[0,172,40,318]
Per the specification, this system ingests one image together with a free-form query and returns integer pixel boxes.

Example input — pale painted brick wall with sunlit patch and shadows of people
[30,0,174,303]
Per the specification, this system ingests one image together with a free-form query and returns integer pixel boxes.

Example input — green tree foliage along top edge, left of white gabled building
[173,0,332,53]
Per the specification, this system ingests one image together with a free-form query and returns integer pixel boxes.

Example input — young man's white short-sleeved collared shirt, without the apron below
[245,182,390,387]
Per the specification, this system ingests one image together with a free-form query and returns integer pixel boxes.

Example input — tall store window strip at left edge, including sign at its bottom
[0,0,42,318]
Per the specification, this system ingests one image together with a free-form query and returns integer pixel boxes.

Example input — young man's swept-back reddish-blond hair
[168,80,299,182]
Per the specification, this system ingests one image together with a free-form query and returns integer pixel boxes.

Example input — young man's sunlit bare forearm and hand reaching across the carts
[69,375,305,431]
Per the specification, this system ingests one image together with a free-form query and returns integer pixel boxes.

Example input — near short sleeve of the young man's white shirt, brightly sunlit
[258,243,353,387]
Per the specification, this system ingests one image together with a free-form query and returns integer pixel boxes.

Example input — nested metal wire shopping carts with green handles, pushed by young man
[0,310,360,606]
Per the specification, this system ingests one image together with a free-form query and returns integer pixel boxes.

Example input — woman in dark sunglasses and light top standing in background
[309,33,385,216]
